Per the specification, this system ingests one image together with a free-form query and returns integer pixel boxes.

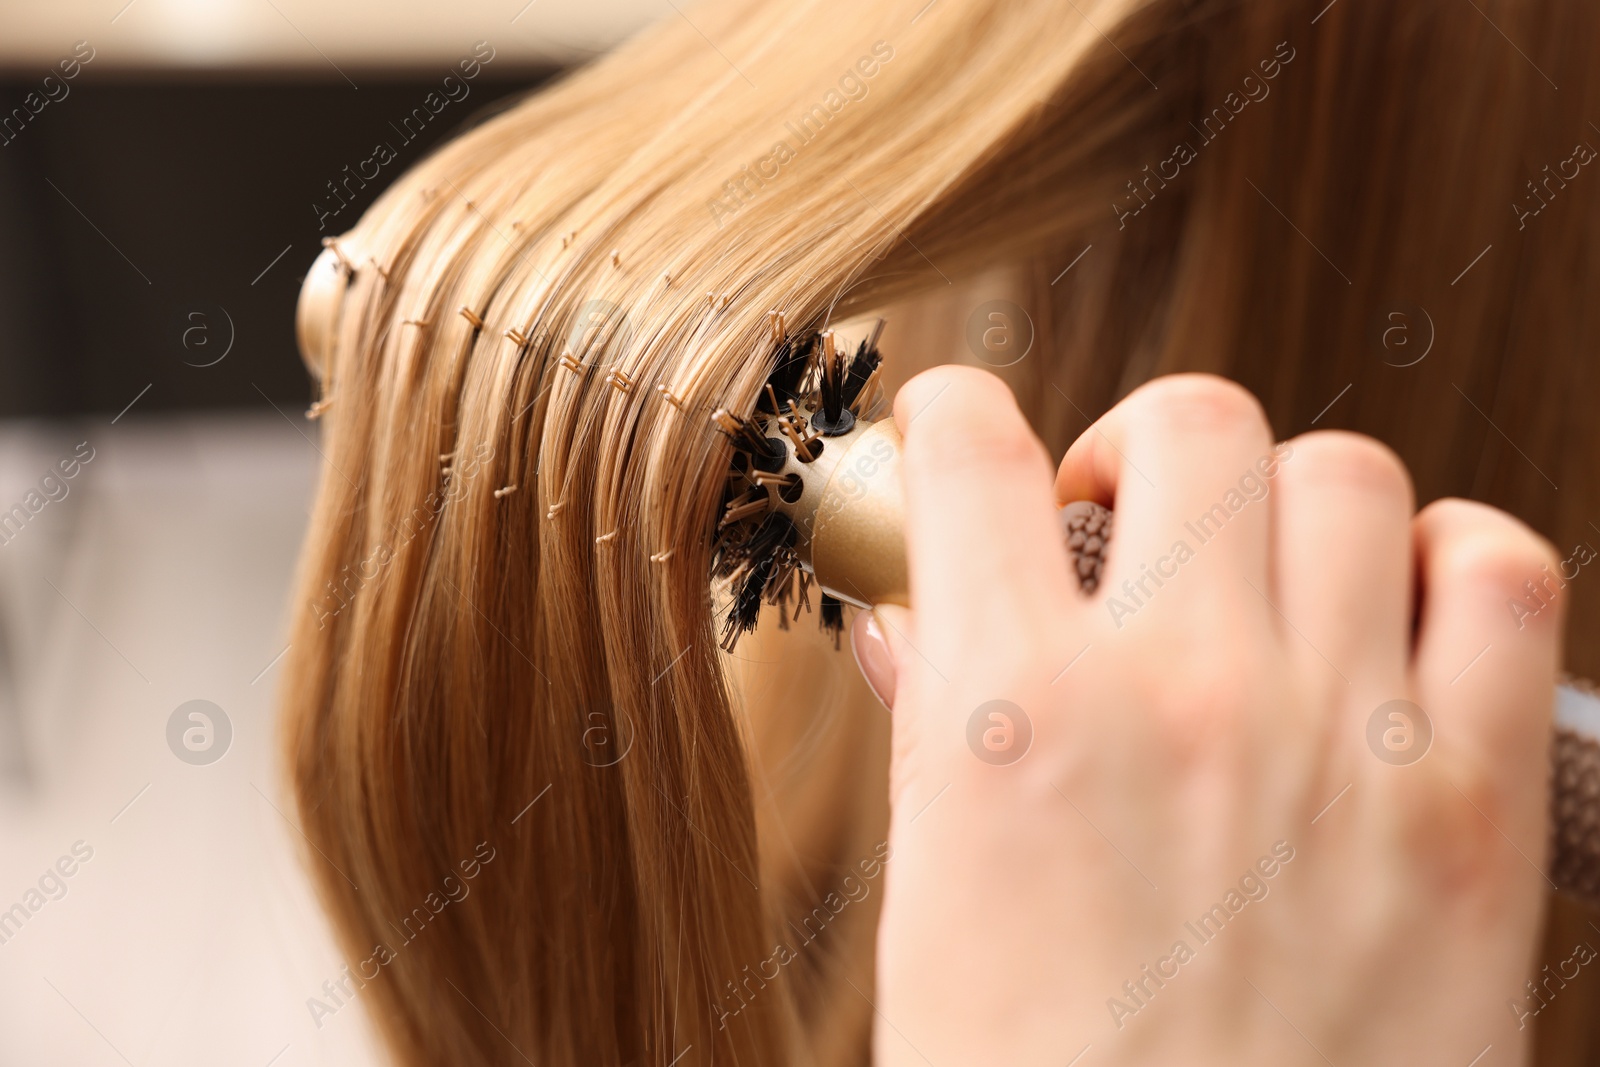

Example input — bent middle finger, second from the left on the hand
[1056,374,1272,598]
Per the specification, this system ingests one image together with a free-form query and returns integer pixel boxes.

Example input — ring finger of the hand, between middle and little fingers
[1267,430,1416,687]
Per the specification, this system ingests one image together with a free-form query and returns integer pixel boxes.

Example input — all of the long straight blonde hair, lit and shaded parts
[285,0,1600,1065]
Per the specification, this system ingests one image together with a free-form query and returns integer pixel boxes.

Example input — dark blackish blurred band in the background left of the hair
[0,68,550,418]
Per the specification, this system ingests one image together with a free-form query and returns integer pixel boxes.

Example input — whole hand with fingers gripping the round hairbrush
[854,368,1562,1067]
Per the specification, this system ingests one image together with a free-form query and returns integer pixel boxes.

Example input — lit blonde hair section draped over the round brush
[286,0,1177,1064]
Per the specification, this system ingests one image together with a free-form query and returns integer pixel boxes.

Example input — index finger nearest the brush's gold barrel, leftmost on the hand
[894,366,1070,645]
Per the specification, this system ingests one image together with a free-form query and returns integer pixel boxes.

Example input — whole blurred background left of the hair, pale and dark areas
[0,0,652,1067]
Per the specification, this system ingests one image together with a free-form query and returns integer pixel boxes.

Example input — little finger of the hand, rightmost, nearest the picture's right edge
[1413,499,1566,790]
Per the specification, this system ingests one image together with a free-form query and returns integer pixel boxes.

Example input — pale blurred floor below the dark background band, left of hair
[0,411,378,1067]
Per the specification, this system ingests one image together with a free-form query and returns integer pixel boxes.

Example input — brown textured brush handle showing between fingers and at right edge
[1059,501,1600,904]
